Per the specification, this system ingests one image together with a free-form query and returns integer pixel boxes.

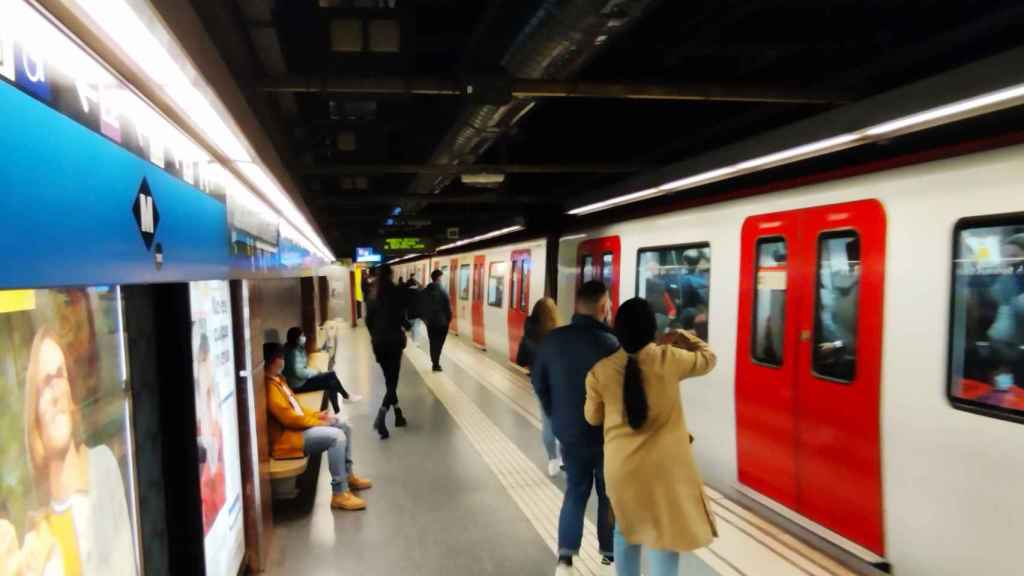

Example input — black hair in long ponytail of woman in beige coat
[615,298,657,429]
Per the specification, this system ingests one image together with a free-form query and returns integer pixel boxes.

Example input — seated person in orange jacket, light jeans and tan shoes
[263,343,373,510]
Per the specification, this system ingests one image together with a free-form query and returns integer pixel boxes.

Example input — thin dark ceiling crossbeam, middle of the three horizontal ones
[302,164,651,176]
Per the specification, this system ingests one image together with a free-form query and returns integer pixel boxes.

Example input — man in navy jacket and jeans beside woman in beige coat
[531,281,618,576]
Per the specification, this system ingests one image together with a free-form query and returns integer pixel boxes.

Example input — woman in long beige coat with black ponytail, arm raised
[585,298,717,576]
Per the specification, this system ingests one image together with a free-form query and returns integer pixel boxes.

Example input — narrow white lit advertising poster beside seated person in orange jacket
[189,280,245,576]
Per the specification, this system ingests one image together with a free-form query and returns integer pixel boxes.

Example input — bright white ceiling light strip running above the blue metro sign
[70,0,335,261]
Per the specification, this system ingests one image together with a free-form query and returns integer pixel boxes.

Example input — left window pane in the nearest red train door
[753,238,787,366]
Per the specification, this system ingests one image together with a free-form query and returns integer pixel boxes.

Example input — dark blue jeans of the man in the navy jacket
[558,444,612,557]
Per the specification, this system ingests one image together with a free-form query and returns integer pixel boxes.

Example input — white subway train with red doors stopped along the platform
[396,136,1024,575]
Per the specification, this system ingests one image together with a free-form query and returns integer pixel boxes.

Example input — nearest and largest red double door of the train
[736,200,886,556]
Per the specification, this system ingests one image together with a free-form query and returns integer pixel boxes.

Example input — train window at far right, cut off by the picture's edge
[949,215,1024,420]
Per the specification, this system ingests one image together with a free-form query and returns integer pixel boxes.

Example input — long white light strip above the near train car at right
[566,78,1024,216]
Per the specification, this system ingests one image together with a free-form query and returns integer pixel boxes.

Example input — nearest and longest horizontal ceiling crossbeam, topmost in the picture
[263,76,853,105]
